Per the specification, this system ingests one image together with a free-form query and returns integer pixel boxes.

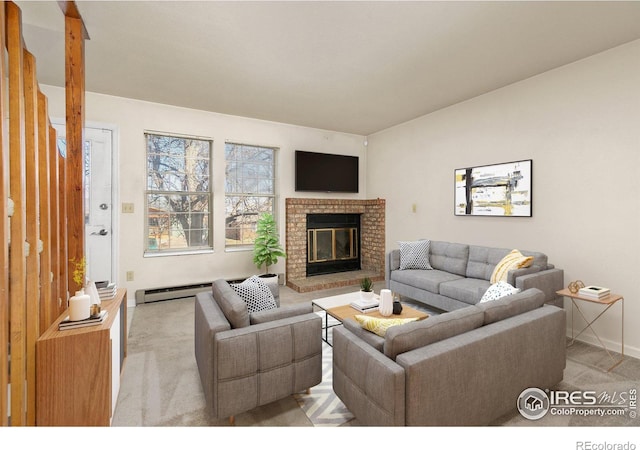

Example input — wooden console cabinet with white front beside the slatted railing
[36,289,127,426]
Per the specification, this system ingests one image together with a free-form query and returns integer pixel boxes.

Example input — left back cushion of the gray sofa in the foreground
[384,306,484,360]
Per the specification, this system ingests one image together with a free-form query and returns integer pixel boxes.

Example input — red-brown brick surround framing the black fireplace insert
[285,198,385,292]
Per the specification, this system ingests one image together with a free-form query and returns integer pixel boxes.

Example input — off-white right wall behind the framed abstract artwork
[367,41,640,356]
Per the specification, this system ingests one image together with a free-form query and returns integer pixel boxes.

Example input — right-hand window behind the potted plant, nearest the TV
[225,143,276,248]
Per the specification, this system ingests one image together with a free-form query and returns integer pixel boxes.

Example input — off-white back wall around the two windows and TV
[41,86,366,305]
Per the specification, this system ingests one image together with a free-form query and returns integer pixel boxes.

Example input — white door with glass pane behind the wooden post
[55,124,115,281]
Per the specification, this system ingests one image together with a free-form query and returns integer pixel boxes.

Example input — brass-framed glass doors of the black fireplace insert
[307,228,358,263]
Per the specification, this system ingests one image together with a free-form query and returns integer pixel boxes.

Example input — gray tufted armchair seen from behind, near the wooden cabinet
[195,280,322,424]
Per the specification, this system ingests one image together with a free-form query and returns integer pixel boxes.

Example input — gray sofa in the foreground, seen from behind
[333,289,566,426]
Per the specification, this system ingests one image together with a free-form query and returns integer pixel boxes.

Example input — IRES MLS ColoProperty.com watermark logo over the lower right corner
[518,388,637,420]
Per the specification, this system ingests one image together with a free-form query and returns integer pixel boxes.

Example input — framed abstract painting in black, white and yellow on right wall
[455,159,532,217]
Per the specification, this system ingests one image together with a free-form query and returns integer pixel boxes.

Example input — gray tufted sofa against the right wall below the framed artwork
[385,241,564,311]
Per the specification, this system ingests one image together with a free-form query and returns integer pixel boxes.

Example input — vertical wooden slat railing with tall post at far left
[0,1,88,426]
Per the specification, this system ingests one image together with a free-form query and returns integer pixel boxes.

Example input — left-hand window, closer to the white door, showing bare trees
[145,133,213,254]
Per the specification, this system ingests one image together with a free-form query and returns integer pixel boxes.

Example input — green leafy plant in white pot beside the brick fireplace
[253,213,287,297]
